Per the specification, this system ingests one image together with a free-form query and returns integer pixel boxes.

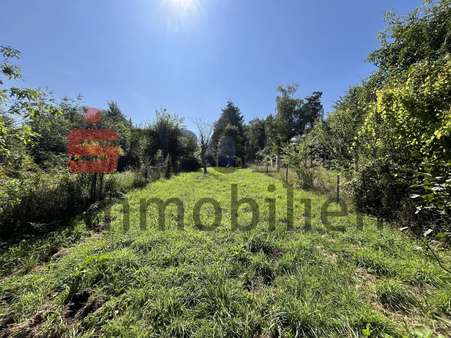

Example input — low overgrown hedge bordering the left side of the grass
[0,170,151,240]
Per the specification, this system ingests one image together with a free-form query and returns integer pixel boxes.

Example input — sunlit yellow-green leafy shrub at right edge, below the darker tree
[354,54,451,229]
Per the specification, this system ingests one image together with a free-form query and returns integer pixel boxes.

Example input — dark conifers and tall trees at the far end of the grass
[208,85,323,166]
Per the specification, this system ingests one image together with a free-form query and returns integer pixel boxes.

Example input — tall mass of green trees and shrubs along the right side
[299,0,451,239]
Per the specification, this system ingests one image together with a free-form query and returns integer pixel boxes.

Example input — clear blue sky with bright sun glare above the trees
[0,0,421,127]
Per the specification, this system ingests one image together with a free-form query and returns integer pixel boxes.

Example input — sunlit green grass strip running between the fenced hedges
[0,169,451,337]
